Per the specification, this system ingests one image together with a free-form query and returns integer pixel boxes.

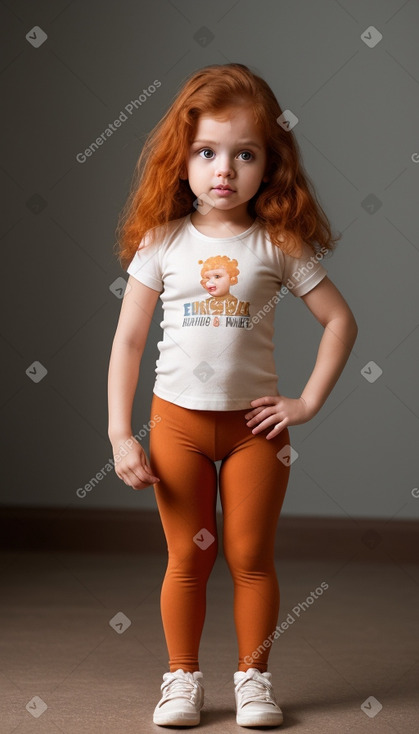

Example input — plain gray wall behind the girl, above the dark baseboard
[0,0,419,519]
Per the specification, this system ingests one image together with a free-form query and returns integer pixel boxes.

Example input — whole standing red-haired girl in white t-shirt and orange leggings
[109,64,357,727]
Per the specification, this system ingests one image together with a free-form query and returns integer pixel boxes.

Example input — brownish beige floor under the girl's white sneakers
[0,549,419,734]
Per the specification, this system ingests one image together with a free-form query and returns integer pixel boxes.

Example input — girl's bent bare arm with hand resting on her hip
[245,276,358,439]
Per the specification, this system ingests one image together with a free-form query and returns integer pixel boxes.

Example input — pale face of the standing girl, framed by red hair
[187,107,267,214]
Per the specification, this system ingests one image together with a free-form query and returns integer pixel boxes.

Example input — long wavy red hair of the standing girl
[116,63,342,268]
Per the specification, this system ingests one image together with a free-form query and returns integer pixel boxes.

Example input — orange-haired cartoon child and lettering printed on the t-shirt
[182,255,250,329]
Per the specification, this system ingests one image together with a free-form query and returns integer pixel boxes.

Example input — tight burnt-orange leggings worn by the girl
[150,393,290,672]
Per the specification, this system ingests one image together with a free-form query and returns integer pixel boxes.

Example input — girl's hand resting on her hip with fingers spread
[245,395,315,438]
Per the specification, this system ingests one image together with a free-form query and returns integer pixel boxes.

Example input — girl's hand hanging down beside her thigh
[112,436,160,489]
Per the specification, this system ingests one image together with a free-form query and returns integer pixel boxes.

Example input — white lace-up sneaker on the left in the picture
[153,668,204,726]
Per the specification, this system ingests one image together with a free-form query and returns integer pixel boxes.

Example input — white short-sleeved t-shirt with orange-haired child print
[127,214,327,410]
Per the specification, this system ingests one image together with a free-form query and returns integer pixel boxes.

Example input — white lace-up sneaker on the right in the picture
[234,668,284,726]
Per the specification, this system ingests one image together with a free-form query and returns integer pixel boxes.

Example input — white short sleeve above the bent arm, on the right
[282,243,327,296]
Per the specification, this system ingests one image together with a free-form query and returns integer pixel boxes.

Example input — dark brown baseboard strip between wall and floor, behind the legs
[0,507,419,564]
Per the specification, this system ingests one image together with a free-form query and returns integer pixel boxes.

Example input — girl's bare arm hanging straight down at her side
[108,275,160,489]
